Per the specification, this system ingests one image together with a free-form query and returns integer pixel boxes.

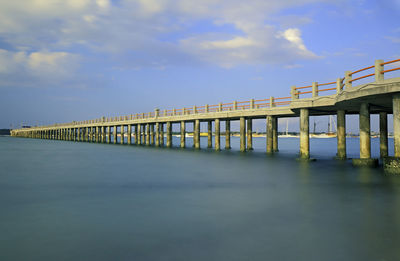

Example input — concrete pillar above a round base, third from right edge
[360,103,371,159]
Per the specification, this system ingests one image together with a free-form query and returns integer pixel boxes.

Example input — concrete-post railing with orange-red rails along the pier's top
[20,59,400,128]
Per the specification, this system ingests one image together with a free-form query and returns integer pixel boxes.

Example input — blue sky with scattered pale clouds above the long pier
[0,0,400,132]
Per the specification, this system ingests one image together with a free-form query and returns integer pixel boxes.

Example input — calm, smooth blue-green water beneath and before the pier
[0,137,400,261]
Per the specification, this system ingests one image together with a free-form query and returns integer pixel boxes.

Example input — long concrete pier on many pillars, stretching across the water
[11,59,400,174]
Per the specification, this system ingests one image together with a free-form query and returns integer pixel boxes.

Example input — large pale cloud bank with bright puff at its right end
[0,0,330,71]
